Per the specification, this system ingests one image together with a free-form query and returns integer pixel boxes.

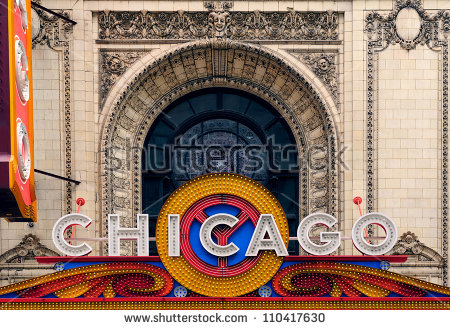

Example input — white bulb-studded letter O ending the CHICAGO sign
[352,212,398,256]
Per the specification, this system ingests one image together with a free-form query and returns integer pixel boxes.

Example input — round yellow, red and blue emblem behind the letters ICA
[156,173,289,297]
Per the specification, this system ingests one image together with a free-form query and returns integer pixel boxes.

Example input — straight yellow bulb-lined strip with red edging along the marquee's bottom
[0,297,450,310]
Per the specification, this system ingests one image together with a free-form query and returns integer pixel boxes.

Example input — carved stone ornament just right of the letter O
[391,231,443,264]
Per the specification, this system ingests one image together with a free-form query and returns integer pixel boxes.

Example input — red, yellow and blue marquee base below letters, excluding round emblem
[0,256,450,310]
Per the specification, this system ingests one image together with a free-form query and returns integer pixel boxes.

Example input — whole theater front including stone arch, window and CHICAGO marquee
[0,0,450,308]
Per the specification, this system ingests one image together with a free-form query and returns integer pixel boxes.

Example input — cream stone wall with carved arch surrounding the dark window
[0,0,450,284]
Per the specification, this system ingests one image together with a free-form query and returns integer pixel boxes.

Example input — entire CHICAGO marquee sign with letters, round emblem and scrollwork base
[0,174,450,309]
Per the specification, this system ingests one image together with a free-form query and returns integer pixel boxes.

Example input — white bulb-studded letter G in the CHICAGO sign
[297,213,341,256]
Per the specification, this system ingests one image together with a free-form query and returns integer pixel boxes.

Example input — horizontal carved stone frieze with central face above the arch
[98,9,339,41]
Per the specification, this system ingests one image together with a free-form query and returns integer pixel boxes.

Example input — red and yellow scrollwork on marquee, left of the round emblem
[0,262,173,298]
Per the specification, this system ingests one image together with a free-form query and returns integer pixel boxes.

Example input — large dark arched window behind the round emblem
[142,88,299,254]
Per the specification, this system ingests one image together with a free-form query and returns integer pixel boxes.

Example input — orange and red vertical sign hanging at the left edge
[0,0,36,221]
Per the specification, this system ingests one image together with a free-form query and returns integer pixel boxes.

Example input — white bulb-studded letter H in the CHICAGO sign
[108,214,149,256]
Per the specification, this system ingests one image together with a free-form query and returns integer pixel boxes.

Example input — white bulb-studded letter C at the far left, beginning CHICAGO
[52,213,92,257]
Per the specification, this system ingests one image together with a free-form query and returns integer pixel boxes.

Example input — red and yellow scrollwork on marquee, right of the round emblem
[272,262,450,297]
